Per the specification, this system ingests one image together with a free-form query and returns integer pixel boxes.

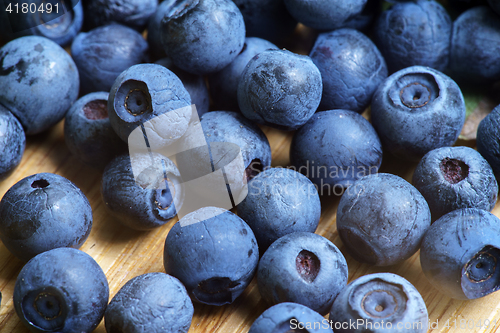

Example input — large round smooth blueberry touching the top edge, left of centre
[160,0,245,75]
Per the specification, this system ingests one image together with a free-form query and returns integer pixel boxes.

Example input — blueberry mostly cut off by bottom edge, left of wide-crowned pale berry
[248,302,333,333]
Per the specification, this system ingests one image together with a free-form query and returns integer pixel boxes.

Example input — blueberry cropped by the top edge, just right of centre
[285,0,367,30]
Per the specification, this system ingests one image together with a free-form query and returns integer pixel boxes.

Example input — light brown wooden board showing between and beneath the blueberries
[0,118,500,333]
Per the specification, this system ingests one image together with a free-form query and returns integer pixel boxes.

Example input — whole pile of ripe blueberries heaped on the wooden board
[0,0,500,333]
